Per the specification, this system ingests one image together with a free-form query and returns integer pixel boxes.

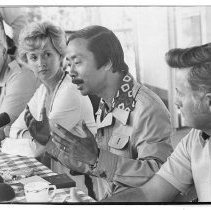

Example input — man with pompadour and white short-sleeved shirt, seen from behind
[104,44,211,202]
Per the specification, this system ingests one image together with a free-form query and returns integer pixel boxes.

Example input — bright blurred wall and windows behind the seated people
[2,6,211,128]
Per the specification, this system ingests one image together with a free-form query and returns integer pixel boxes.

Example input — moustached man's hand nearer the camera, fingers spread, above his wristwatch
[52,122,98,165]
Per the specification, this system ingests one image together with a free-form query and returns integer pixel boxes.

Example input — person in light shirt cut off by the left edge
[0,21,40,141]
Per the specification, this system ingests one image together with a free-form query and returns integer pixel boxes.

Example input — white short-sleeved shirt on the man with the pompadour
[157,129,211,202]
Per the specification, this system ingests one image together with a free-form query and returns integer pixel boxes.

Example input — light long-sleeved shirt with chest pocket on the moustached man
[91,75,172,200]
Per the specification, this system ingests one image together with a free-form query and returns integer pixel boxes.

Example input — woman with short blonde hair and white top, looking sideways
[5,22,96,190]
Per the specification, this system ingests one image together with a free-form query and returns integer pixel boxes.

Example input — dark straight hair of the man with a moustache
[67,25,128,74]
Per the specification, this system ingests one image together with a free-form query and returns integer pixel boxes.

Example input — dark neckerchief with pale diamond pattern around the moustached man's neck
[99,74,135,121]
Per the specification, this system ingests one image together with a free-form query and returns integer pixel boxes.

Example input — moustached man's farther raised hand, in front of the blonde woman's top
[24,105,50,145]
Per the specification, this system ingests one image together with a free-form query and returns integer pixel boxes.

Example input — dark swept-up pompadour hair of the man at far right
[166,44,211,92]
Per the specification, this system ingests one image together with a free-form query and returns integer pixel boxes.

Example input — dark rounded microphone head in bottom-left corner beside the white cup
[0,183,15,202]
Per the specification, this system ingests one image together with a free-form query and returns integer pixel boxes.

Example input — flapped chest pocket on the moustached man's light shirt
[108,135,130,157]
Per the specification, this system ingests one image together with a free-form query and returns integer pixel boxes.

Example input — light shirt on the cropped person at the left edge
[0,60,40,123]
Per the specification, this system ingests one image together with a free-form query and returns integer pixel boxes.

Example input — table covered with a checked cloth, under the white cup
[0,152,95,203]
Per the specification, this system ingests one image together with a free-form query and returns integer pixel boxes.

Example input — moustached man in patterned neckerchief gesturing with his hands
[45,26,172,200]
